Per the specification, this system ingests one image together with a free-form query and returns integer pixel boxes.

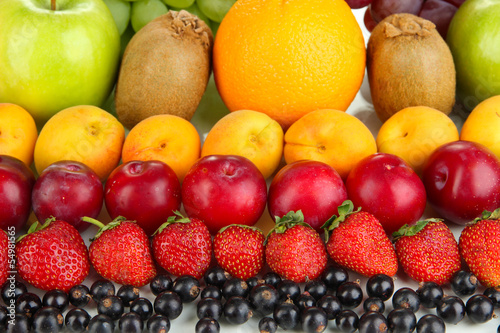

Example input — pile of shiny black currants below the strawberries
[0,266,500,333]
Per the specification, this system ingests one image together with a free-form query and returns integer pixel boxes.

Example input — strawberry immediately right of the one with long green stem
[152,212,212,279]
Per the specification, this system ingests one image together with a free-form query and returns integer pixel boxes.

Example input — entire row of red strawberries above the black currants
[0,201,500,291]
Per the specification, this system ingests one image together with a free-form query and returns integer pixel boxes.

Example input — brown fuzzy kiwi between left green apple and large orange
[115,10,213,129]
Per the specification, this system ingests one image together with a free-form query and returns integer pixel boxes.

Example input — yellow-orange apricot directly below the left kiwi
[122,114,201,182]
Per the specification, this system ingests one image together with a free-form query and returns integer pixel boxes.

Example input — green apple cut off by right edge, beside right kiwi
[446,0,500,112]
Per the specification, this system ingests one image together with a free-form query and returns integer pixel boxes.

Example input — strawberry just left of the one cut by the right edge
[393,219,461,285]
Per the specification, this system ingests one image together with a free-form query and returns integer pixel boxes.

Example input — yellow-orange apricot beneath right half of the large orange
[283,109,377,180]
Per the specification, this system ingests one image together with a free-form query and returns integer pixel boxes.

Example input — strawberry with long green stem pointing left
[82,216,156,287]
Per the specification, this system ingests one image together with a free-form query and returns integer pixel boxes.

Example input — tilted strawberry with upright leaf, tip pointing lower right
[322,200,398,276]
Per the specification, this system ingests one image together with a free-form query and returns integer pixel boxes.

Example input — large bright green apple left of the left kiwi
[0,0,120,127]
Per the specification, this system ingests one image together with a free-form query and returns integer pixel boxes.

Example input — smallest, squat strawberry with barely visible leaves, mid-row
[214,224,266,280]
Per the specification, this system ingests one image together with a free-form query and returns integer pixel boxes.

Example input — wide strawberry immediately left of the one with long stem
[16,219,90,292]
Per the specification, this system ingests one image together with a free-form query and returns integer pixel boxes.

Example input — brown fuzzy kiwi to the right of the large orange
[366,13,456,122]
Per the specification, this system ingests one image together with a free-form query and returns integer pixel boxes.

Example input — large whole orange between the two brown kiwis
[213,0,366,129]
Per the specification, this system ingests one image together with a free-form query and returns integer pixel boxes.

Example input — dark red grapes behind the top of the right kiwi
[346,0,465,39]
